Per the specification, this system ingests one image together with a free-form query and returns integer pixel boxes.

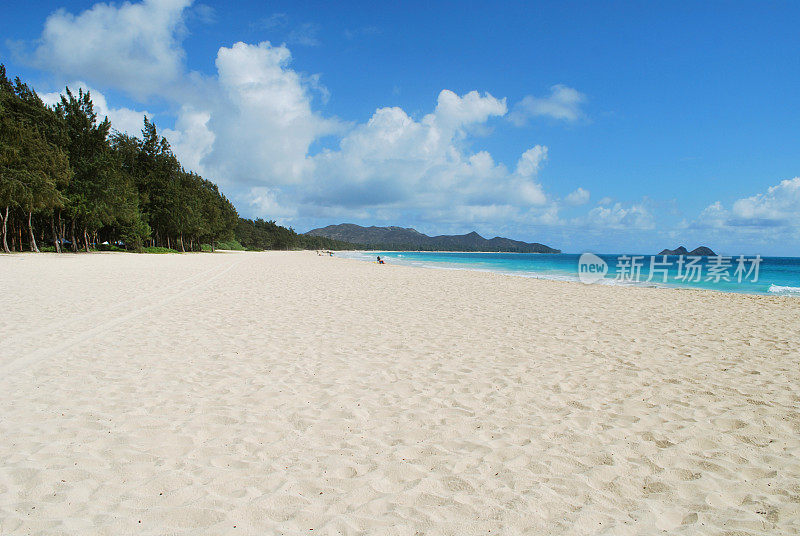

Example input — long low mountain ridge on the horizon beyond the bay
[306,223,561,253]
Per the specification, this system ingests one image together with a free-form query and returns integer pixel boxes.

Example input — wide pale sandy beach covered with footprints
[0,253,800,536]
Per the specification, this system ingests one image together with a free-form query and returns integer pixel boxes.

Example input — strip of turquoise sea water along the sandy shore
[337,251,800,297]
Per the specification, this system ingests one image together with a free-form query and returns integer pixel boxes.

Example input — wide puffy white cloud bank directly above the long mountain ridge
[300,90,547,224]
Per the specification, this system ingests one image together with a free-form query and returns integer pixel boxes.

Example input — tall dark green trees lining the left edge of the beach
[0,65,238,252]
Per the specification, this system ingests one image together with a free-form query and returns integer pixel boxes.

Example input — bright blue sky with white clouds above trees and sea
[0,0,800,255]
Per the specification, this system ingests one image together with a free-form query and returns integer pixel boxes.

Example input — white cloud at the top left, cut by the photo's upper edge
[31,0,191,98]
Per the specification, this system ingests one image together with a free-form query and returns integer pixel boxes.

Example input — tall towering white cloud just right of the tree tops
[198,42,340,186]
